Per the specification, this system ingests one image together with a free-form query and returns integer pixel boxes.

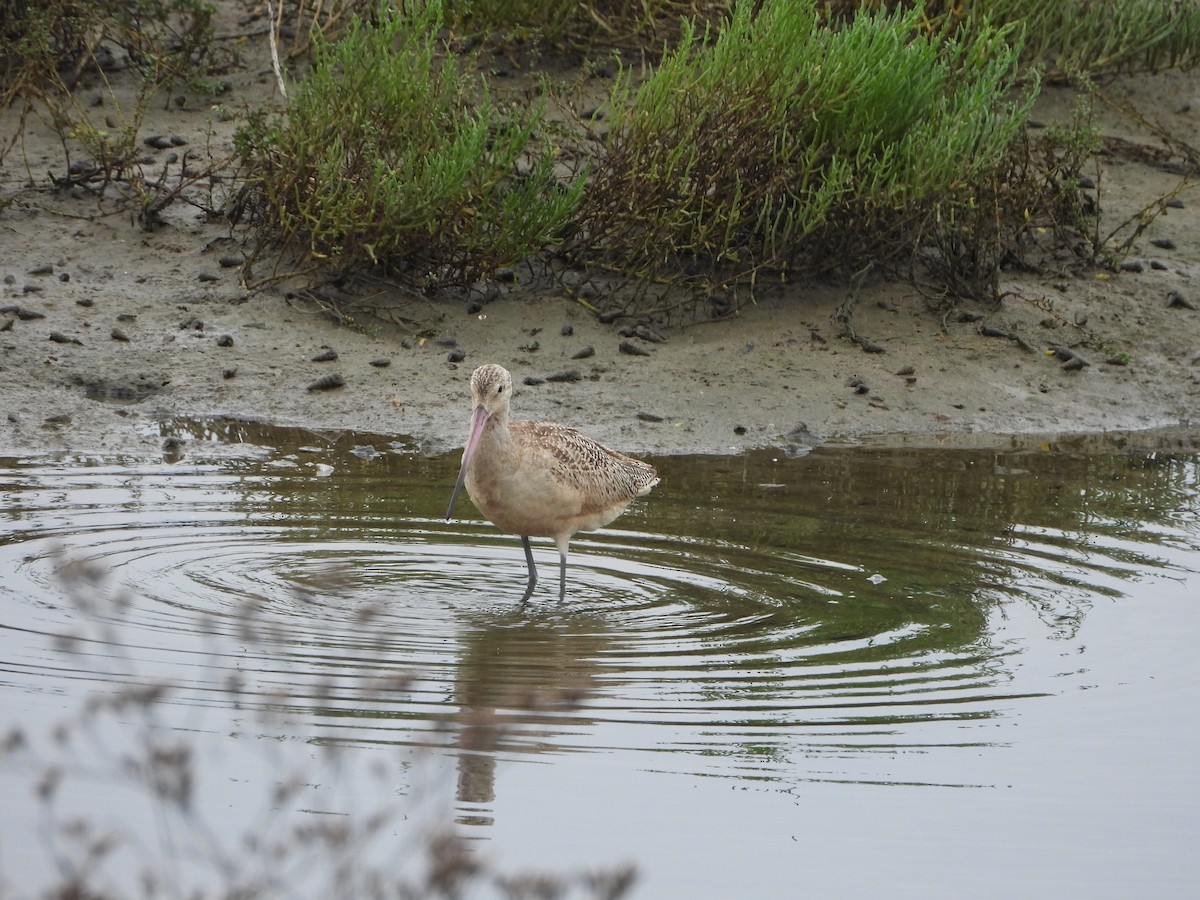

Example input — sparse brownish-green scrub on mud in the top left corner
[0,0,228,217]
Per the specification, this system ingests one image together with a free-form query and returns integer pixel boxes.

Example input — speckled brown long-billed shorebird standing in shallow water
[446,365,659,604]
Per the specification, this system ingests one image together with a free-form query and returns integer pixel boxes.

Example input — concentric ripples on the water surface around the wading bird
[0,436,1196,782]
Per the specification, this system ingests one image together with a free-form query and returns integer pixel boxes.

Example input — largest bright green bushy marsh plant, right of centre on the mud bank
[574,0,1034,309]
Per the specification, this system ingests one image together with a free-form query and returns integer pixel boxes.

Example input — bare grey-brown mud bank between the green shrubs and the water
[0,30,1200,456]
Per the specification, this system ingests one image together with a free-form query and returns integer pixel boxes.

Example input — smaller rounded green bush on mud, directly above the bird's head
[238,2,583,288]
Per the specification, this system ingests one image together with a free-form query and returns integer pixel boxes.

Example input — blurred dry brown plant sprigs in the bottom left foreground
[0,557,637,900]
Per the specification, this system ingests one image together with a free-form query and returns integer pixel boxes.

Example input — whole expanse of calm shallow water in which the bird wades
[0,424,1200,898]
